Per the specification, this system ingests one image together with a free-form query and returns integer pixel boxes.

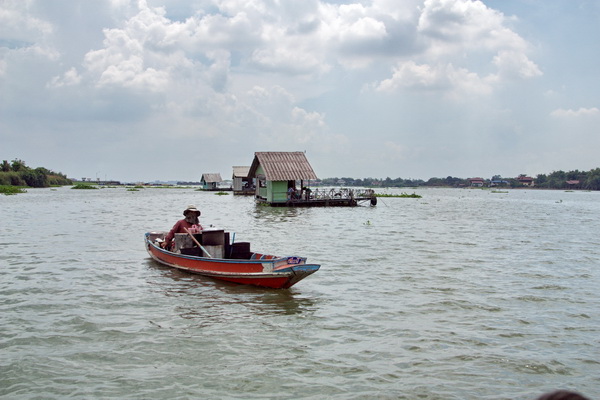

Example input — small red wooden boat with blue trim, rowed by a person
[145,230,320,289]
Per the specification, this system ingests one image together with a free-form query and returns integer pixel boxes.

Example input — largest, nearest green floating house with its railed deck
[248,151,377,207]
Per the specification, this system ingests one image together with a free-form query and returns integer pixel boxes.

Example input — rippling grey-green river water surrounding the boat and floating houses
[0,188,600,399]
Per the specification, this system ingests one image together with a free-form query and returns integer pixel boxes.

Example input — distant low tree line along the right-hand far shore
[321,168,600,190]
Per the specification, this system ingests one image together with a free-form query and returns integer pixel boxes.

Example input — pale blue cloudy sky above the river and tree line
[0,0,600,182]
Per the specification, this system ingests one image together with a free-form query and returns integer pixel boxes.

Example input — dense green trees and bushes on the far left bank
[0,159,73,187]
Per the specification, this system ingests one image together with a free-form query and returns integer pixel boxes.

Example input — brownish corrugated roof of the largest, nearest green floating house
[248,151,317,181]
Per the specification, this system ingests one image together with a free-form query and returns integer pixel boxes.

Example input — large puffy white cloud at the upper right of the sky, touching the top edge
[372,0,542,99]
